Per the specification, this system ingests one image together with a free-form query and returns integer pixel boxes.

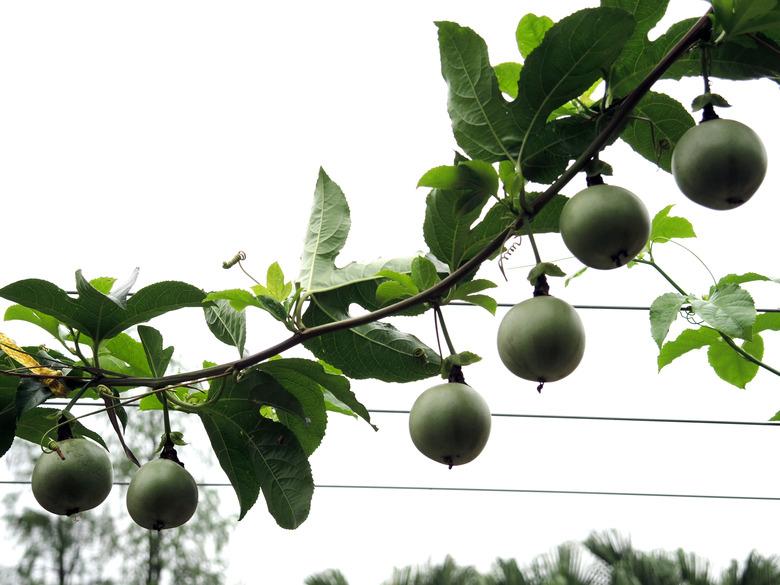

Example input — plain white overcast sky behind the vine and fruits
[0,0,780,585]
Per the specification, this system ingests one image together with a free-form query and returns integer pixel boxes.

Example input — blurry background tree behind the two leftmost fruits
[3,413,234,585]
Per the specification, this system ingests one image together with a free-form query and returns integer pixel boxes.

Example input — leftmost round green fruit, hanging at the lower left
[32,438,113,516]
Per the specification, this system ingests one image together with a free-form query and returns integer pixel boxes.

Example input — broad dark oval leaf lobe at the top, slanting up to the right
[511,8,634,176]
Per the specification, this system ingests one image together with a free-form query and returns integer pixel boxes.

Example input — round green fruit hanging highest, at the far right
[672,119,767,209]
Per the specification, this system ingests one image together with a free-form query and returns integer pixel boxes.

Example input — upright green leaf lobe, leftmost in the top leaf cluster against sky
[436,22,522,162]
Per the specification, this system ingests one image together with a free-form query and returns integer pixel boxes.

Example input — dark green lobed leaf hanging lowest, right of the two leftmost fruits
[198,372,314,529]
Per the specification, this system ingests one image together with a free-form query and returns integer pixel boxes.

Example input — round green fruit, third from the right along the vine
[498,296,585,382]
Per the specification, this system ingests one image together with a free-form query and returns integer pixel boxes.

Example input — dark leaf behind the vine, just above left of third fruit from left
[303,282,440,382]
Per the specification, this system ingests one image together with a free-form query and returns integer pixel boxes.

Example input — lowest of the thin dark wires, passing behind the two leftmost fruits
[0,480,780,502]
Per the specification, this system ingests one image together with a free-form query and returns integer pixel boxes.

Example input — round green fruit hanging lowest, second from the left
[127,459,198,530]
